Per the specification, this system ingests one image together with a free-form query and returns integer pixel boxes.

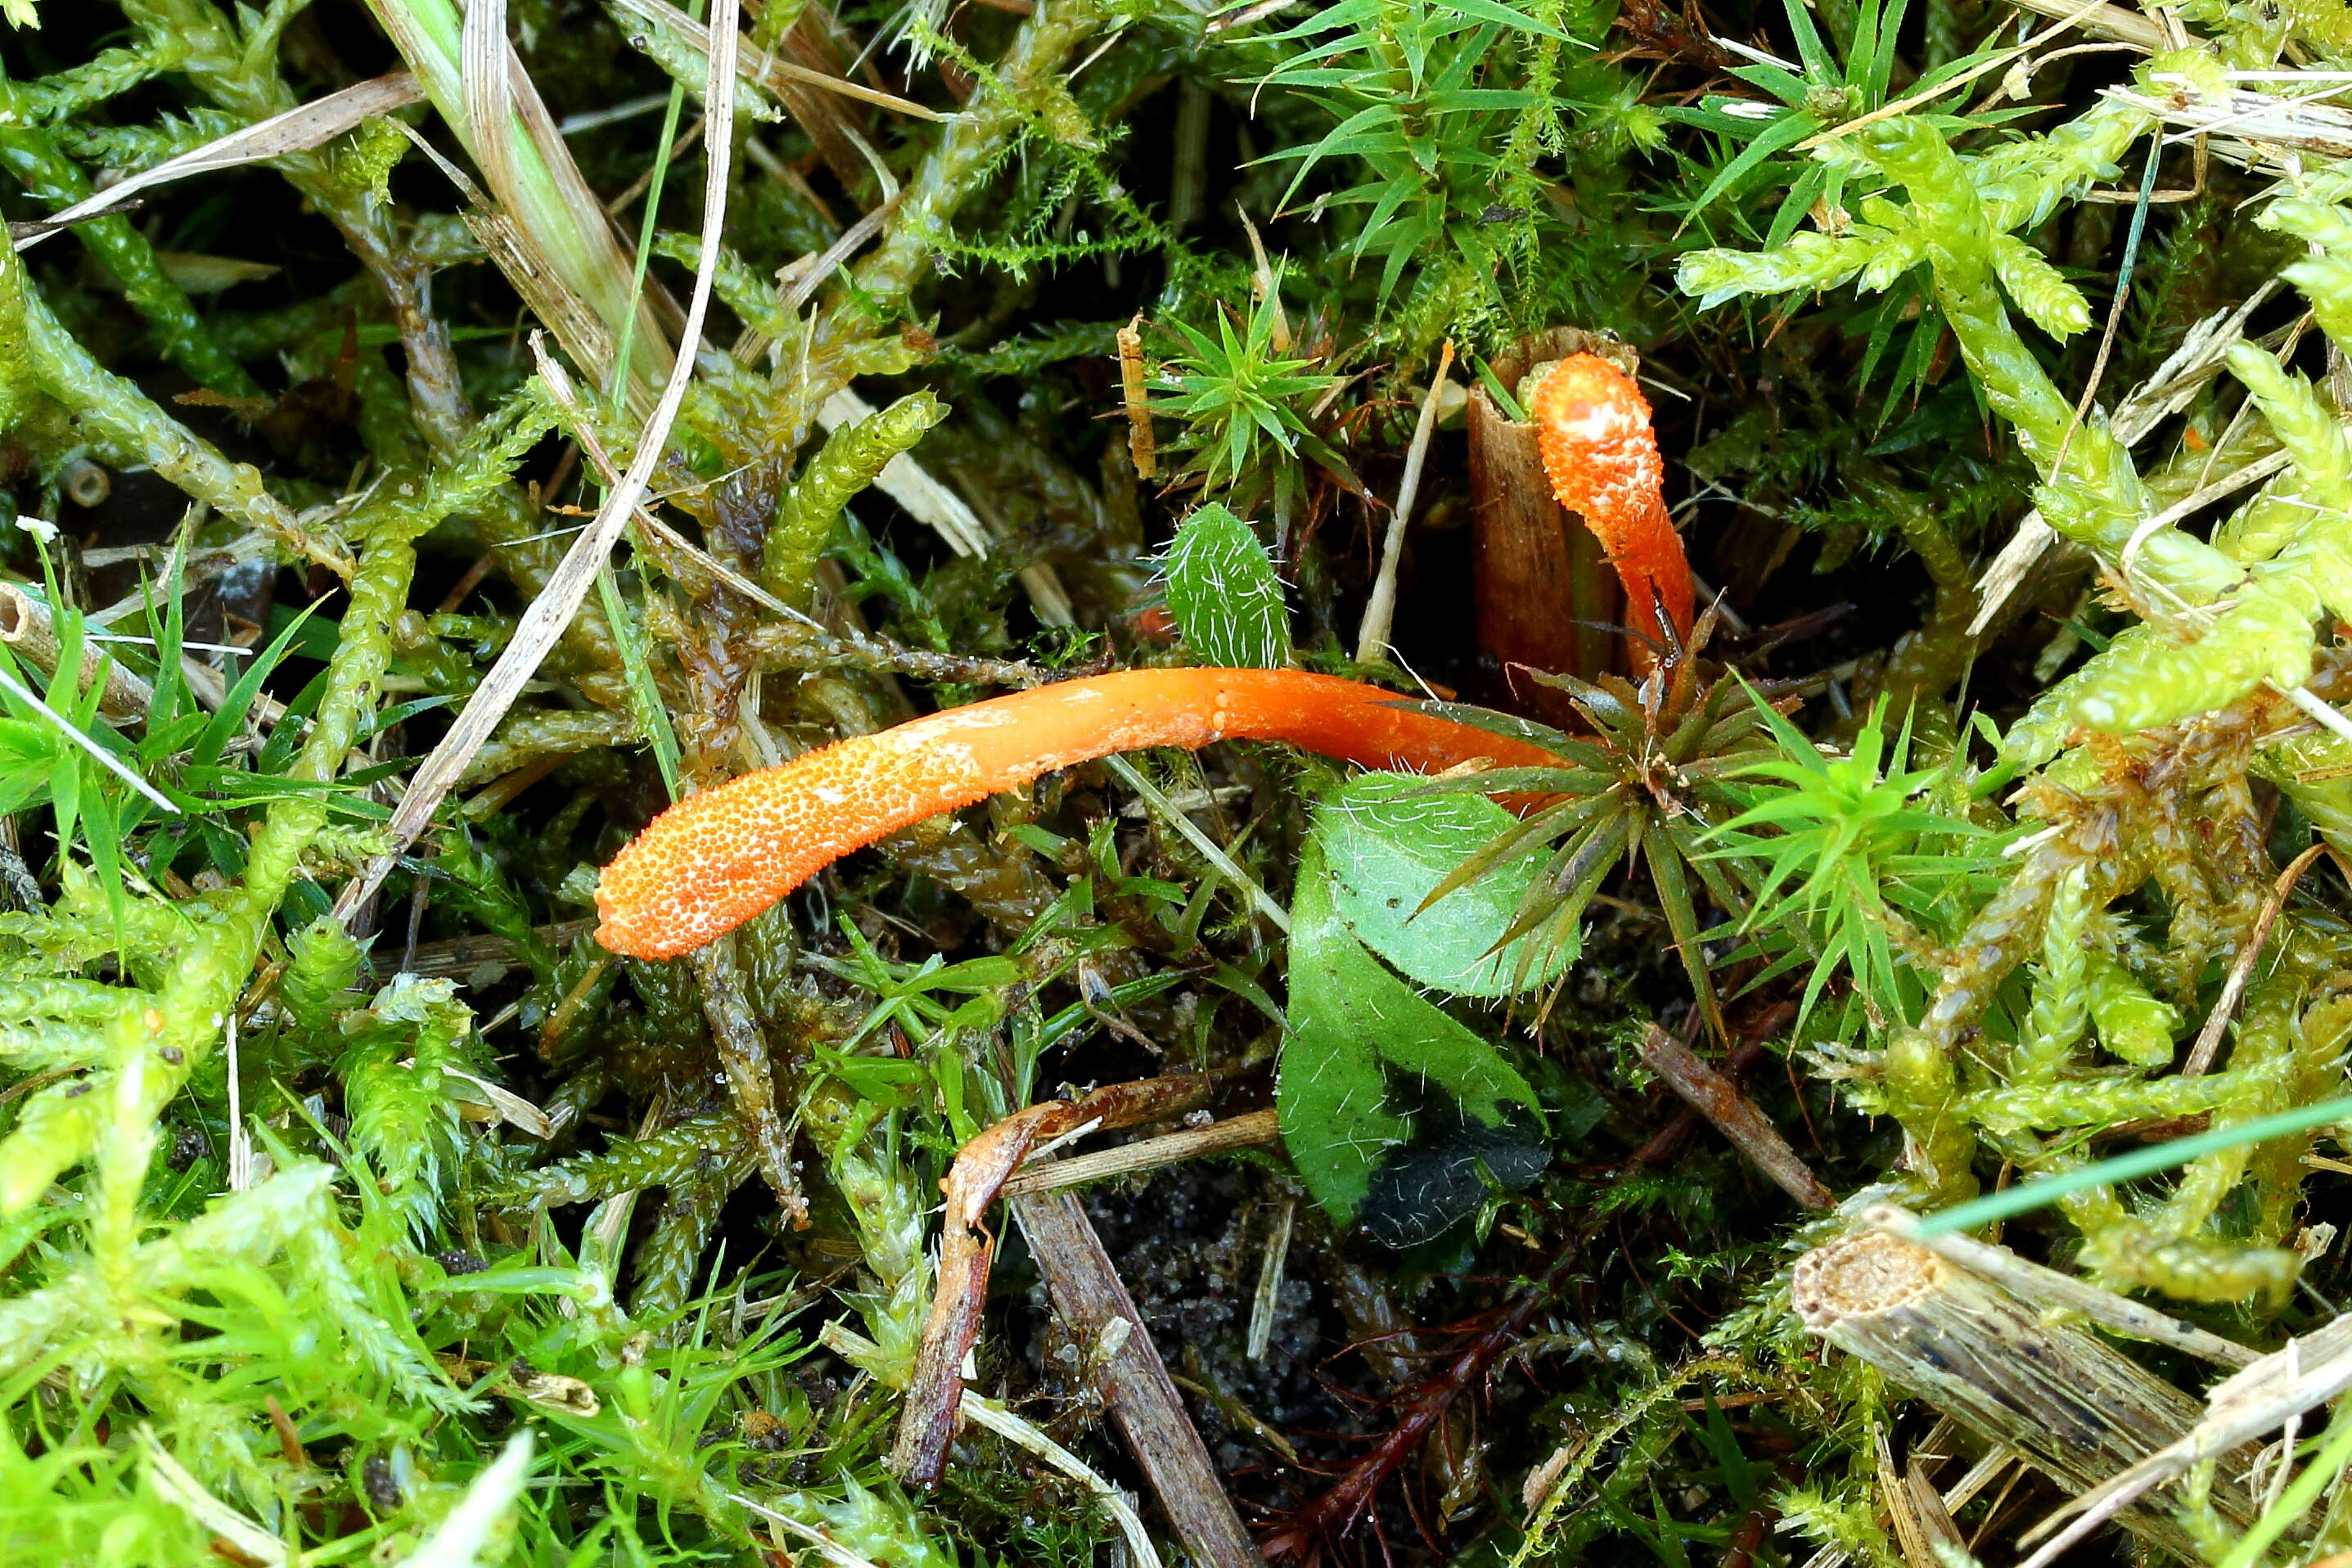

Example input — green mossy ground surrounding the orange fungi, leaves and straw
[0,0,2352,1568]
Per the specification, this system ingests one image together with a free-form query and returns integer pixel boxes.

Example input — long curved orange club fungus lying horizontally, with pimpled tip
[595,670,1559,959]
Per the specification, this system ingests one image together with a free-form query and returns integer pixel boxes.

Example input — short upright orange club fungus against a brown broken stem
[1526,355,1691,639]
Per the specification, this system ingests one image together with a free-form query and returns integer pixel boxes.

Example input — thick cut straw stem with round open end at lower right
[1790,1232,2267,1561]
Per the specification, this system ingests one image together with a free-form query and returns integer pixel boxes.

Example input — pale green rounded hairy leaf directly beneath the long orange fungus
[1317,773,1566,997]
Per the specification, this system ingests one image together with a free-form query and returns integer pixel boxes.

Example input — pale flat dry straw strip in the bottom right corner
[2018,1314,2352,1568]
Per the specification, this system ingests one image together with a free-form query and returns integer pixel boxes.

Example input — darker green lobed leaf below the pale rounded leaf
[1275,832,1548,1246]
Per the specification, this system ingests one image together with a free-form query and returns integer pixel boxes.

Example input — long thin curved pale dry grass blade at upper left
[334,0,741,924]
